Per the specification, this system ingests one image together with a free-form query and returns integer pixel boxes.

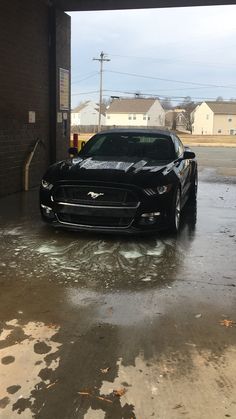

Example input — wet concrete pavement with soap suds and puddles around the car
[0,147,236,419]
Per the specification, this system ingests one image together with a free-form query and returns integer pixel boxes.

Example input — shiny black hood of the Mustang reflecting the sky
[46,157,173,186]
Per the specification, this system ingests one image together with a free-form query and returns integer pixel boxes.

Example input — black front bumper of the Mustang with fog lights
[40,183,172,234]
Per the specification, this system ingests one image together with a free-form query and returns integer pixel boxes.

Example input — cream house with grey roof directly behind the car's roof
[106,98,165,128]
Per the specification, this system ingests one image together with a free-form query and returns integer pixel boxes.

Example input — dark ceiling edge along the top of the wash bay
[54,0,236,11]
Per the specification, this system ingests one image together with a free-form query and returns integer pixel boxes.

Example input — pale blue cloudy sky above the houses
[70,6,236,107]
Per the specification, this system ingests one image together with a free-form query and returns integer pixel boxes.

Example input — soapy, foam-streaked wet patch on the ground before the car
[0,202,196,289]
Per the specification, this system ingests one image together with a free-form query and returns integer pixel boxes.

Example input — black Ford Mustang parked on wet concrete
[40,129,198,233]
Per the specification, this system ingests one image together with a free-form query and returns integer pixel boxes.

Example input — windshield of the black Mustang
[79,133,175,160]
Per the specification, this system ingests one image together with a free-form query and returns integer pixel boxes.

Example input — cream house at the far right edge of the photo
[191,101,236,135]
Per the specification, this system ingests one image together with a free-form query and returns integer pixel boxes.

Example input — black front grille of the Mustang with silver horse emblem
[53,185,139,228]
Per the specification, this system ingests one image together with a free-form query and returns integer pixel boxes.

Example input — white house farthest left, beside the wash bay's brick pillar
[71,100,106,126]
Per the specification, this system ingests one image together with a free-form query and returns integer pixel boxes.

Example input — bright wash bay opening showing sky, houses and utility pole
[71,6,236,159]
